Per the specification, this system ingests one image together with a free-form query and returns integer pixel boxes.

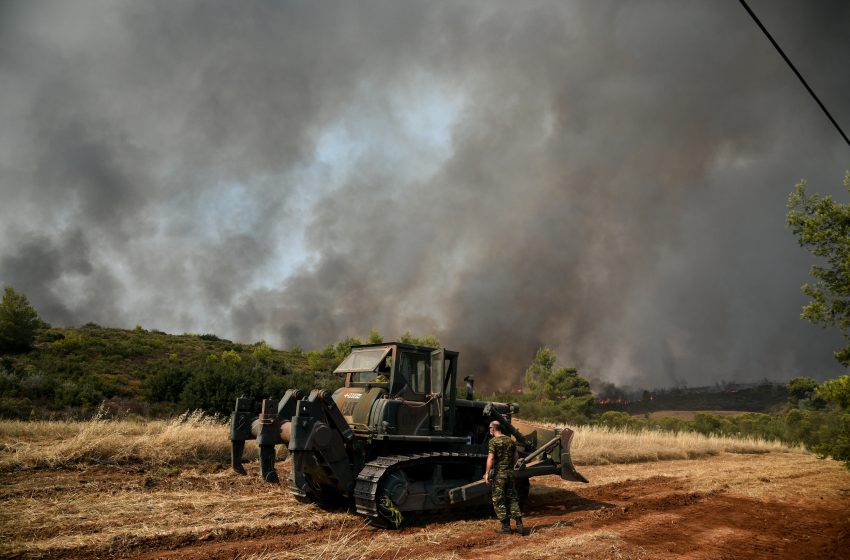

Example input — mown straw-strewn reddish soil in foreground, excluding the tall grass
[0,453,850,560]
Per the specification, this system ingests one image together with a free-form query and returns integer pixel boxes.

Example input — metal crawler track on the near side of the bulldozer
[354,451,489,526]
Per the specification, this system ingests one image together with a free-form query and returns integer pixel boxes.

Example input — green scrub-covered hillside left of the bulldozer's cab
[0,324,345,418]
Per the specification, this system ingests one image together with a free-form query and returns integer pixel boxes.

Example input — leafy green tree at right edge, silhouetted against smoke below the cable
[786,171,850,366]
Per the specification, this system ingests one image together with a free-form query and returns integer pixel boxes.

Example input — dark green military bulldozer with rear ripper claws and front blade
[230,342,587,527]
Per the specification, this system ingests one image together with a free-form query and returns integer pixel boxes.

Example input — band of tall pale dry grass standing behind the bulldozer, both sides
[0,411,802,471]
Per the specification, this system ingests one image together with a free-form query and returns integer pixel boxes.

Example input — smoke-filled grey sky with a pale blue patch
[0,0,850,389]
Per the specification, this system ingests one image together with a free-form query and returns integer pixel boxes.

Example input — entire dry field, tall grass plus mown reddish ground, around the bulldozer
[0,415,850,560]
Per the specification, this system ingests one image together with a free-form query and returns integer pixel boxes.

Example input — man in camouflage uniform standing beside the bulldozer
[484,420,525,535]
